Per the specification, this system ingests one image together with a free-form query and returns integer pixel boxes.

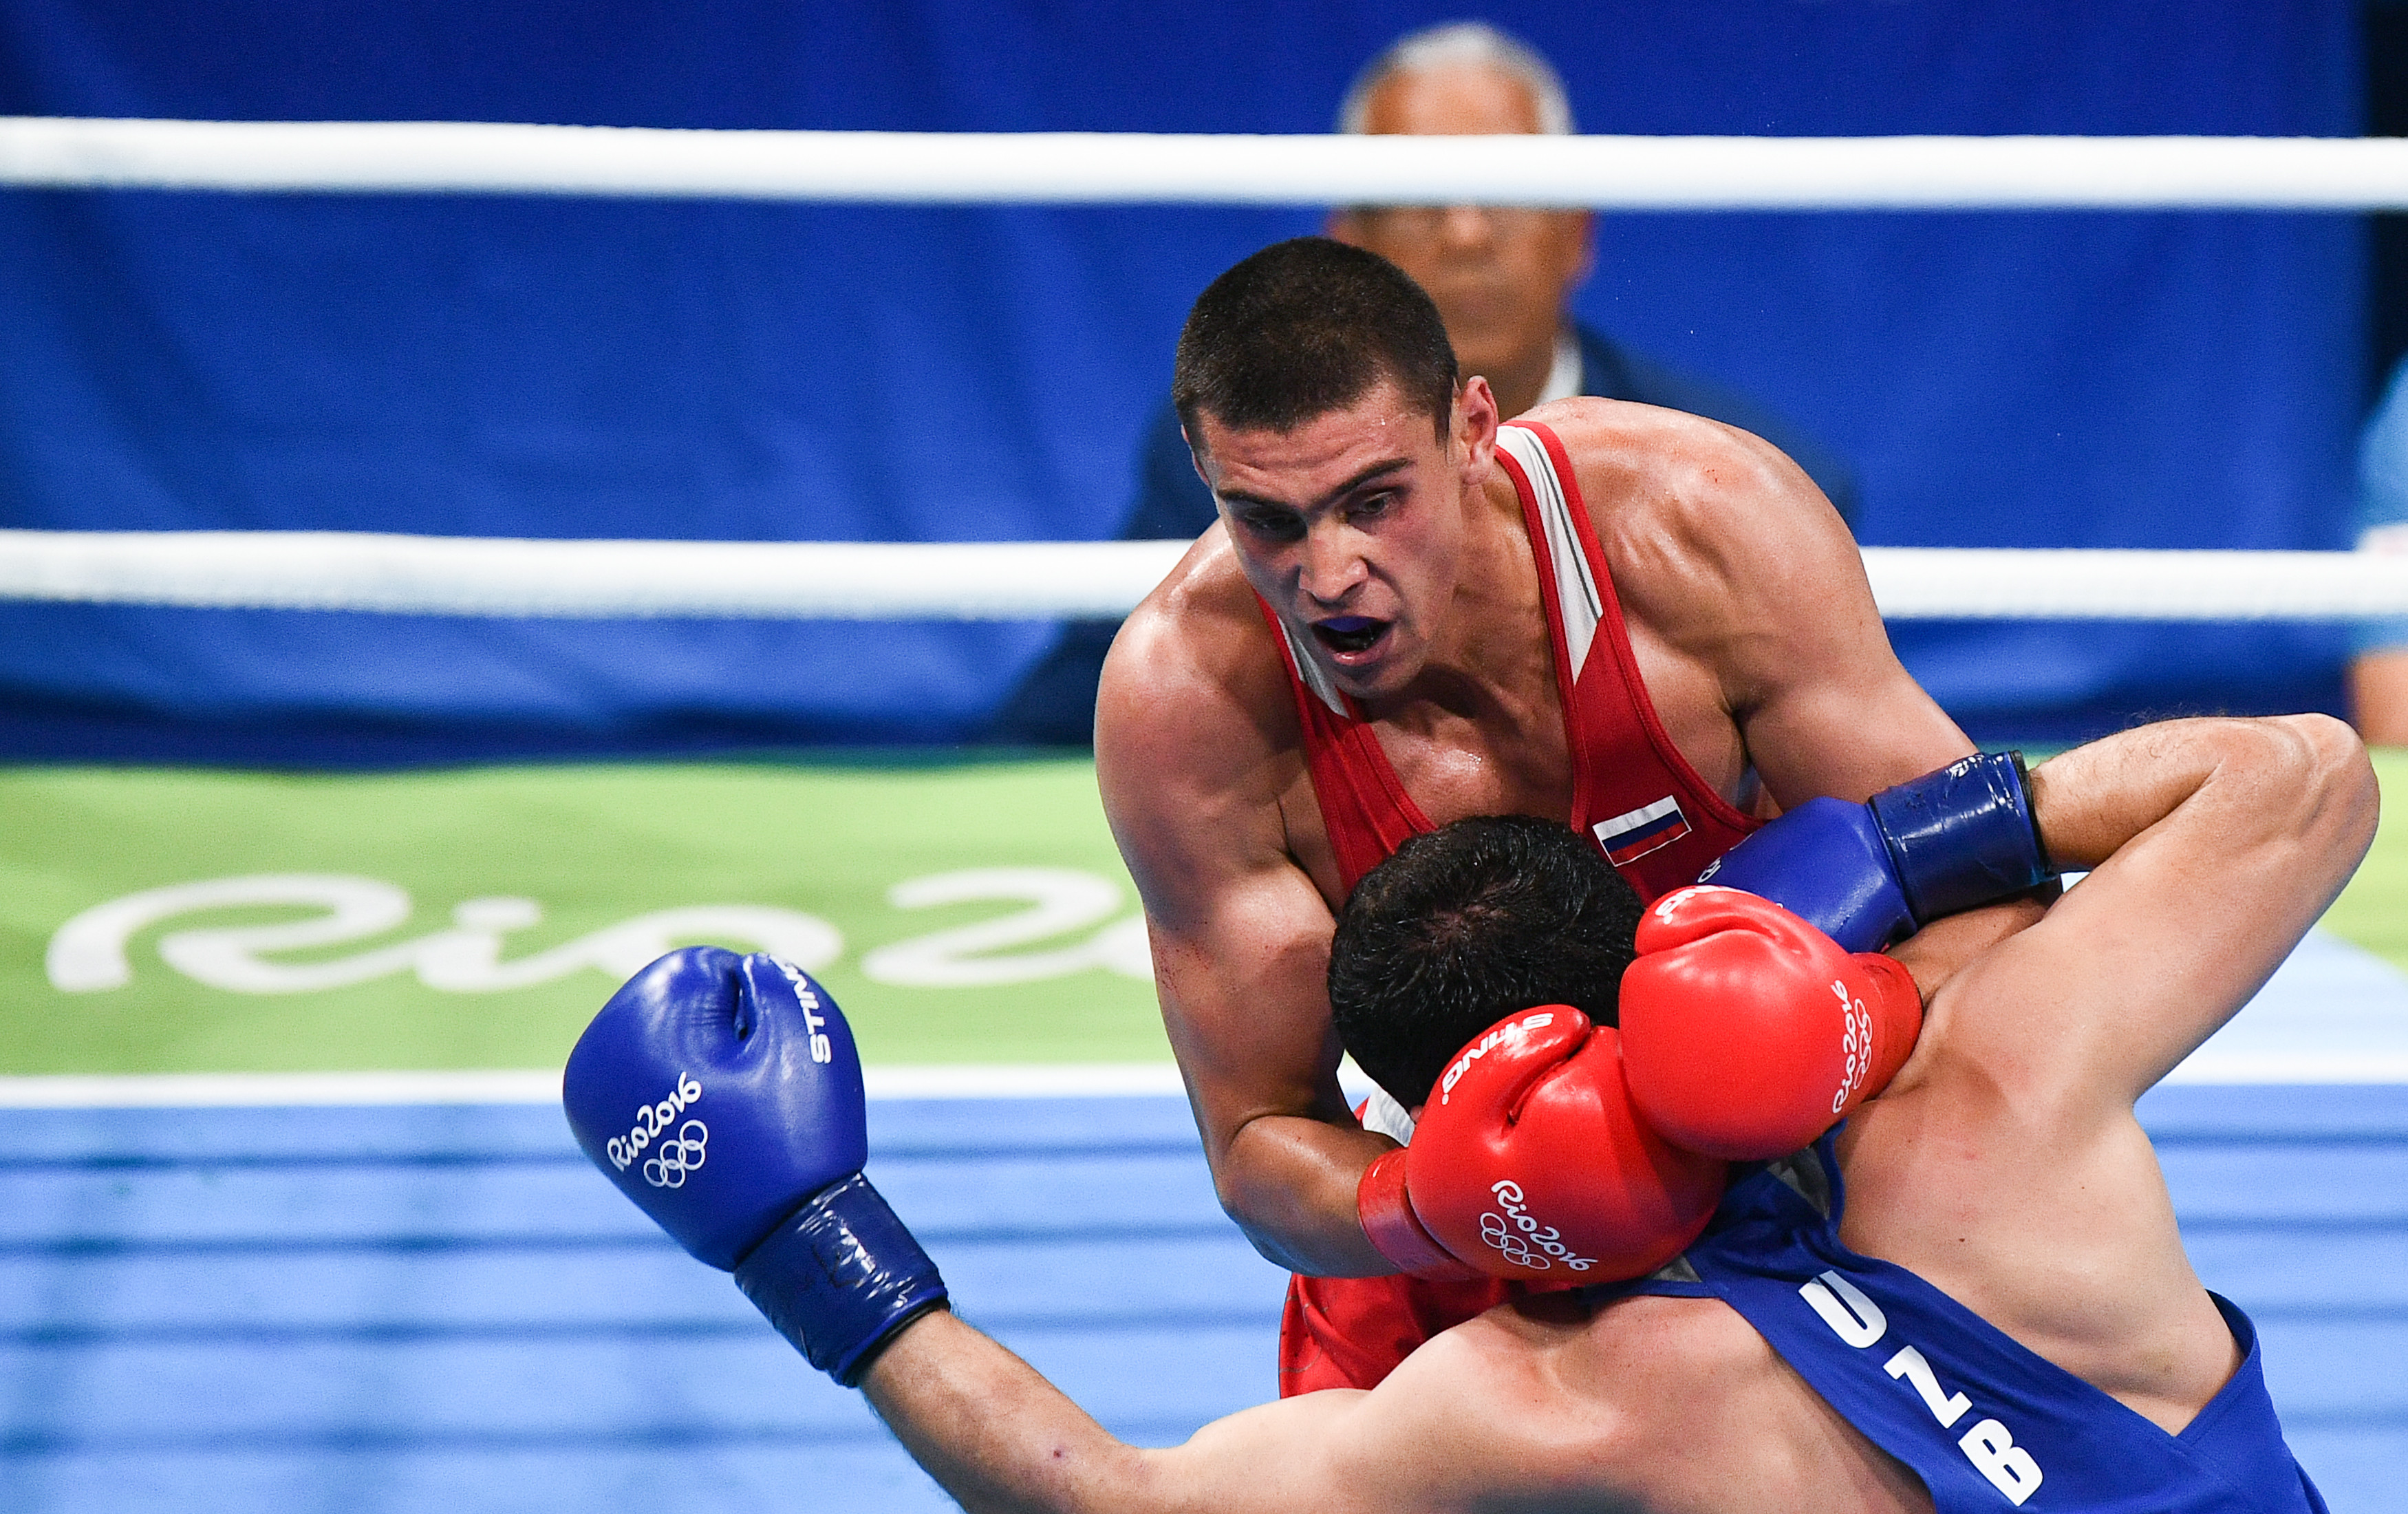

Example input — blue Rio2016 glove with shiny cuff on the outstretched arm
[561,946,944,1387]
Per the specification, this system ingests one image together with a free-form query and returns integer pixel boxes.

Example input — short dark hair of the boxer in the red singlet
[1170,236,1457,440]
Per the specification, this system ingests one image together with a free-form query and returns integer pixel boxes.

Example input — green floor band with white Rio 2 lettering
[0,751,2408,1076]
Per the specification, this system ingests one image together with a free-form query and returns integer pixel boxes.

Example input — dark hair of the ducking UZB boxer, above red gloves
[1329,816,1640,1109]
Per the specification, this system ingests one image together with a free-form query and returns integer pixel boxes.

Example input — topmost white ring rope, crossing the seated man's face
[0,116,2408,209]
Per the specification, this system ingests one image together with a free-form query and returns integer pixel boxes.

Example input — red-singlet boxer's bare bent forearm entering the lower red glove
[1214,1114,1397,1278]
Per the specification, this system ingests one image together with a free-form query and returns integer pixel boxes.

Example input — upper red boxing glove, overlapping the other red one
[1621,886,1924,1162]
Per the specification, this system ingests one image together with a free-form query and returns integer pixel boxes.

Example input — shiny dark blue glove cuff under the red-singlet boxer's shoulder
[1871,751,2054,924]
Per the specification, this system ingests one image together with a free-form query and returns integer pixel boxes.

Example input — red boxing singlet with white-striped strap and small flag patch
[1262,421,1761,1396]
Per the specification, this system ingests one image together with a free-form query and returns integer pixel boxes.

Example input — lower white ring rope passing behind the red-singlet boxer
[0,529,2408,621]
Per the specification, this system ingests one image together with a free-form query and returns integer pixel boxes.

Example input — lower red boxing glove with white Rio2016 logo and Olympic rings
[1401,1004,1727,1288]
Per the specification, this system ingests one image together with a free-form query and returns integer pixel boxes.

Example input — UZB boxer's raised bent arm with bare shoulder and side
[1842,715,2377,1430]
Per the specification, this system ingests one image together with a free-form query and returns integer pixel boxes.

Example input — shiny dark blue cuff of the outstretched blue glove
[737,1172,944,1389]
